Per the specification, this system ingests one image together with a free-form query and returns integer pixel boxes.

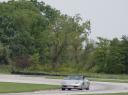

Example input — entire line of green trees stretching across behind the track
[0,0,128,73]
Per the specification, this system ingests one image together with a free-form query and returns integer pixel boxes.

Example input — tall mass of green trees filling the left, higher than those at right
[0,0,90,71]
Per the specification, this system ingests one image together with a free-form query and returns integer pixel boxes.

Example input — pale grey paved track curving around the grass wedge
[0,74,128,95]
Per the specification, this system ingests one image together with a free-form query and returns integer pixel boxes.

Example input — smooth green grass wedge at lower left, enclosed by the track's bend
[0,82,60,93]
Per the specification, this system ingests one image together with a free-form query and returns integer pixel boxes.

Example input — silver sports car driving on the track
[62,76,90,90]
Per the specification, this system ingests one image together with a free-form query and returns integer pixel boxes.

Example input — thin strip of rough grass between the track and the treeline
[0,65,128,80]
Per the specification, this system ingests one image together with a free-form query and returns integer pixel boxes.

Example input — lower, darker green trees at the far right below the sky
[91,36,128,74]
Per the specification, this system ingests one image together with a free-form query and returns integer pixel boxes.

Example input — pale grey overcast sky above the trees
[43,0,128,39]
